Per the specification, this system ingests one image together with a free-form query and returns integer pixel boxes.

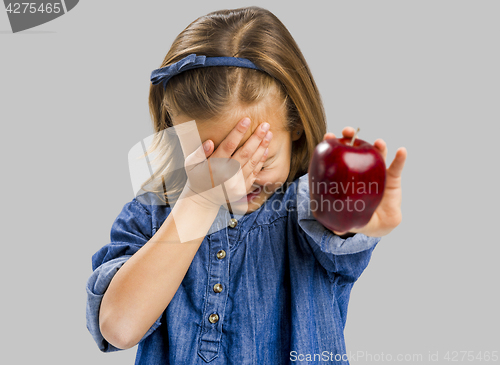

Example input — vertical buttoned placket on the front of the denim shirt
[198,208,237,362]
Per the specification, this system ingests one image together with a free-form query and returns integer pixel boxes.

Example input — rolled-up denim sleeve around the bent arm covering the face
[86,198,162,352]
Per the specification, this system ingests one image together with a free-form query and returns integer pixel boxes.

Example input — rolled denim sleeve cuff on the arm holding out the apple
[297,174,381,282]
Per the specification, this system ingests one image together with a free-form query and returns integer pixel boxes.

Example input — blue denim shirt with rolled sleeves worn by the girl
[86,174,380,365]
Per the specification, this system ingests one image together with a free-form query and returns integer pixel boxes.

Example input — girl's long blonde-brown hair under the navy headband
[143,6,326,205]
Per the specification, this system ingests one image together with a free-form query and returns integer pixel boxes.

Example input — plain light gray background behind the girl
[0,0,500,365]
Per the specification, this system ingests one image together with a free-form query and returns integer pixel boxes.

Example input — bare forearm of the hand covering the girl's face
[99,189,218,348]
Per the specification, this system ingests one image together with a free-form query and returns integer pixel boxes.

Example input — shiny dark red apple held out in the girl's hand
[309,129,386,232]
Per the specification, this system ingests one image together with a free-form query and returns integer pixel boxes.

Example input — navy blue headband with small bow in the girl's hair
[151,53,263,89]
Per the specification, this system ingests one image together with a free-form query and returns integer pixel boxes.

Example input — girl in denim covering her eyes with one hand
[87,7,406,365]
